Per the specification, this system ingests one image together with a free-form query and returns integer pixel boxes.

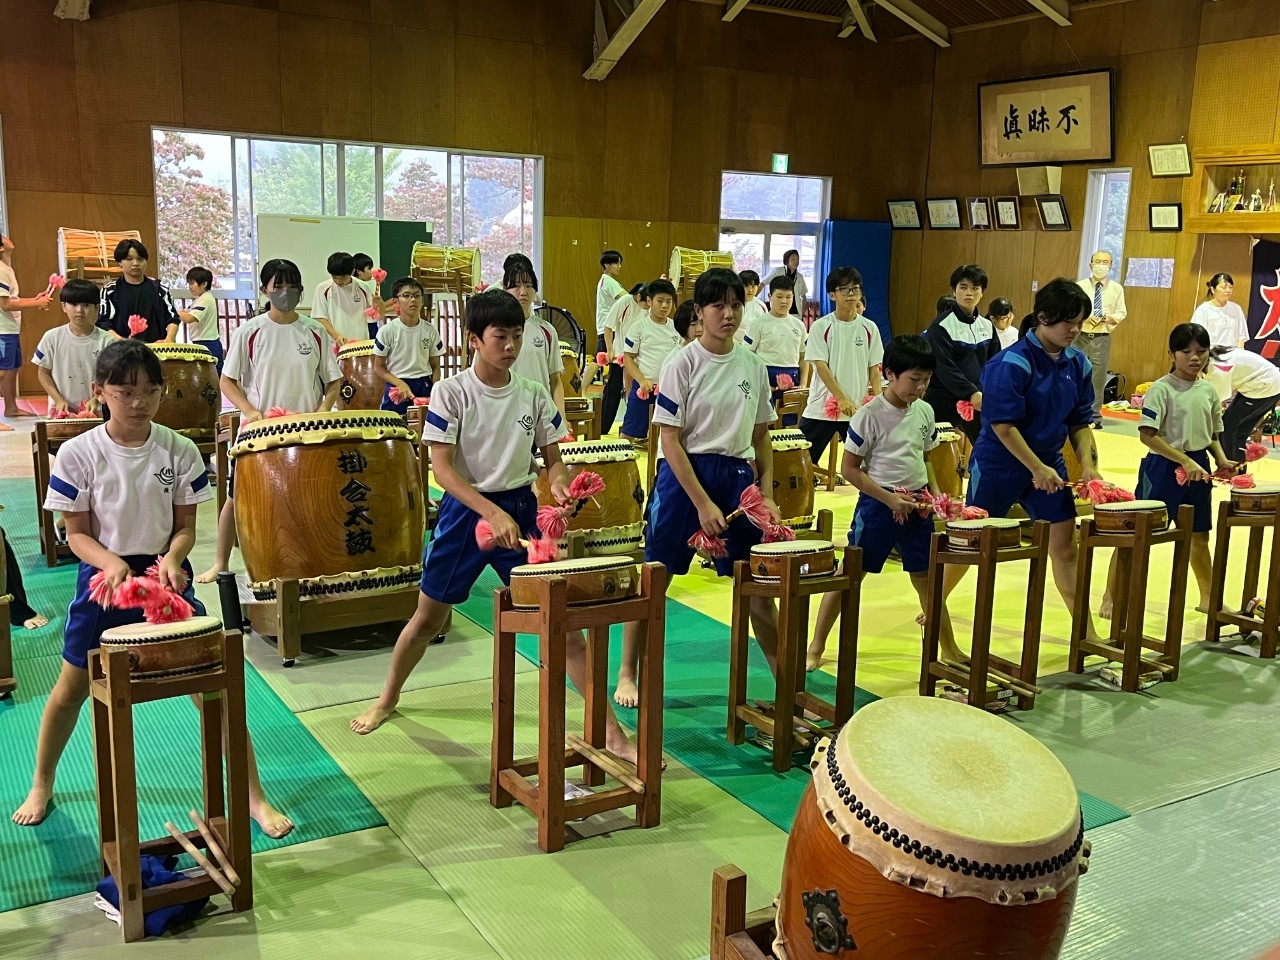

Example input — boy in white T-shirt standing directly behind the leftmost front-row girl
[31,280,116,416]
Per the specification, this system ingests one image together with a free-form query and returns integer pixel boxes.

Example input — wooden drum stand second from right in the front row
[1068,504,1194,694]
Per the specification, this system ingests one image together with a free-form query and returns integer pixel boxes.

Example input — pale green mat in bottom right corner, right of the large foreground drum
[1064,768,1280,960]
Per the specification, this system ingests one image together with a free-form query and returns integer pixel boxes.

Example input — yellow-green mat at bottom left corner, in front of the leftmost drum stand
[0,827,498,960]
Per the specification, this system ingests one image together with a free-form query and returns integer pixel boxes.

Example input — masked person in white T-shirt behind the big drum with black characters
[196,260,342,584]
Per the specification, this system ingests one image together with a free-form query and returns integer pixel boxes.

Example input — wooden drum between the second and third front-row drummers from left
[535,440,644,556]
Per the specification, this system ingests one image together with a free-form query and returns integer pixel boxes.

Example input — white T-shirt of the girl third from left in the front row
[653,340,777,460]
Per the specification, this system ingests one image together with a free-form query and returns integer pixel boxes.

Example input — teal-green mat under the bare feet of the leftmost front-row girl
[0,657,384,910]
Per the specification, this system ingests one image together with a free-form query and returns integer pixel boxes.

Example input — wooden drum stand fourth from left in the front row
[920,520,1050,710]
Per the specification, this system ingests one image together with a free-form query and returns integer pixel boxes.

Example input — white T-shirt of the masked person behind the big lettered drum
[223,314,342,413]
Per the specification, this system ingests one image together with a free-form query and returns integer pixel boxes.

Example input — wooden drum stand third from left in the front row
[724,547,863,773]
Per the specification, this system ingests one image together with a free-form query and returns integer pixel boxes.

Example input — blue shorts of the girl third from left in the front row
[644,453,763,577]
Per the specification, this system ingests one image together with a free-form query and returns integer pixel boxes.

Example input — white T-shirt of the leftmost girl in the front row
[45,424,214,557]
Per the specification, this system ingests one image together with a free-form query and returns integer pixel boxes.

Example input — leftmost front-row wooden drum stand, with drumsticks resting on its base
[88,632,253,943]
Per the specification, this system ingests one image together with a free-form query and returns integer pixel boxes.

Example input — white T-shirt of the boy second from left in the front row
[422,367,564,493]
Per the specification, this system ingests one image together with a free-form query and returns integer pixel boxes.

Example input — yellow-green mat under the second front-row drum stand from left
[301,675,787,960]
